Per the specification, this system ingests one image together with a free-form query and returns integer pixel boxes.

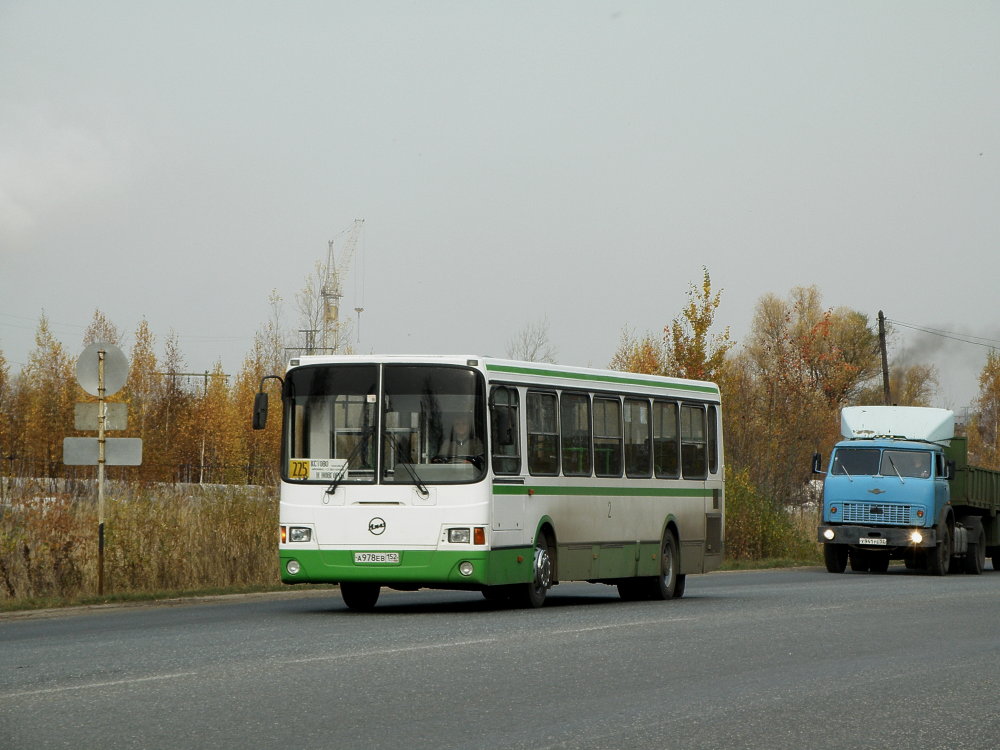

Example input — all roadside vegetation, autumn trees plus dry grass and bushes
[0,269,1000,610]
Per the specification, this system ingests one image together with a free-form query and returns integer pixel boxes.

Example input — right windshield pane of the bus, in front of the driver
[382,365,486,484]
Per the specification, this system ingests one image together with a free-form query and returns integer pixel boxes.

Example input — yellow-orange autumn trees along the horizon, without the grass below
[0,269,1000,496]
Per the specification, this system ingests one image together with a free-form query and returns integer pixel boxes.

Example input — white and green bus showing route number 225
[254,355,725,610]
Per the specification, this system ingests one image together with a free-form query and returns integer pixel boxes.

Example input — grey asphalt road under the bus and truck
[0,568,1000,750]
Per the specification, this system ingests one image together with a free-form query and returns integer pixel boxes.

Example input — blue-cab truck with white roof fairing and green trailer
[813,406,1000,575]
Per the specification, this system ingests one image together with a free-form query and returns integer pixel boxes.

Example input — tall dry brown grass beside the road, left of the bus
[0,483,279,606]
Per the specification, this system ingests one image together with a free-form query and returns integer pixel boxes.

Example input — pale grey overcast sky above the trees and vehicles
[0,0,1000,408]
